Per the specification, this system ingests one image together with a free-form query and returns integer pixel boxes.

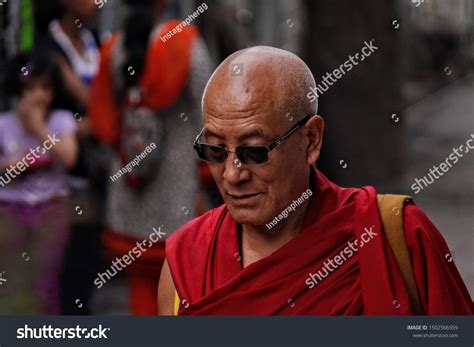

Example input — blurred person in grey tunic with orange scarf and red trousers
[89,0,212,315]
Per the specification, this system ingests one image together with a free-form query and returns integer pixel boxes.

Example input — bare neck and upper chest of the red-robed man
[239,202,308,267]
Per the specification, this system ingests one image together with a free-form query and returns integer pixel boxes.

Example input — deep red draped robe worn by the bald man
[166,172,473,315]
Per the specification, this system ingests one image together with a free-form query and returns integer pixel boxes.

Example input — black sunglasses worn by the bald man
[193,113,313,164]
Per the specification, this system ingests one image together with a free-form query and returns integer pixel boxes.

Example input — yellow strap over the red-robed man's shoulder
[377,194,423,315]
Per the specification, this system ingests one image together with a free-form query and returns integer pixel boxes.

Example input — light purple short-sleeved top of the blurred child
[0,110,76,205]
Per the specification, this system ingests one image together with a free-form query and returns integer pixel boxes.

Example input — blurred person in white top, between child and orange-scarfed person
[36,0,104,314]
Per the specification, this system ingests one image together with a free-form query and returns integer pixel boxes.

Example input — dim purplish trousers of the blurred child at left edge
[0,198,70,315]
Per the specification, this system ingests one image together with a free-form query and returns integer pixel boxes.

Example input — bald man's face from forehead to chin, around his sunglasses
[201,65,321,226]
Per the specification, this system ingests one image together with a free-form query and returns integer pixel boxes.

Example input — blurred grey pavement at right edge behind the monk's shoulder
[404,74,474,297]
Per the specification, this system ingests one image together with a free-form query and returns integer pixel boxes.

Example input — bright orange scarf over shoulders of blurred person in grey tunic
[88,20,198,144]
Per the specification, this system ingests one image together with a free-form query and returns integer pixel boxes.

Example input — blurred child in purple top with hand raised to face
[0,54,77,314]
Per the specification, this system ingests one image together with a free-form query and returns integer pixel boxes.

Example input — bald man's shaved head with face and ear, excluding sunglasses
[200,46,324,232]
